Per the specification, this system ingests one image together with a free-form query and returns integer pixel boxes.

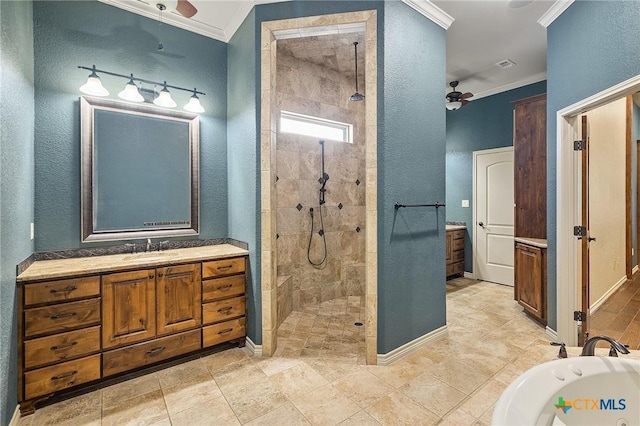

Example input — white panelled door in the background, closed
[473,147,514,286]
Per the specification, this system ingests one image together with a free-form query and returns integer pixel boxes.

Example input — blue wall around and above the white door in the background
[446,81,547,272]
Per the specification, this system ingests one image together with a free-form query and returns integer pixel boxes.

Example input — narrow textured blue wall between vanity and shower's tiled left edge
[227,11,262,344]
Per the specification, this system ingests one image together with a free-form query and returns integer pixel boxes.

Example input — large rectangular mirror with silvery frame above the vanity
[80,96,200,241]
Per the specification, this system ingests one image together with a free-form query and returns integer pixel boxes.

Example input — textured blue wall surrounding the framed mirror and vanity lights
[33,1,228,251]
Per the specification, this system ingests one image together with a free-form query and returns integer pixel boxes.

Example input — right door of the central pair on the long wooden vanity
[156,263,202,335]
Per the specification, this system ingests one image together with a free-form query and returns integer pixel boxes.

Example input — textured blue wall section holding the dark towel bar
[378,2,446,353]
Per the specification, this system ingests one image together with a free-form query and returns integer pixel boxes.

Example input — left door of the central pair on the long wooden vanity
[102,269,156,348]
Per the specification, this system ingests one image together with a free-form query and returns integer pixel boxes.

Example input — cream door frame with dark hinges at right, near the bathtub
[547,75,640,346]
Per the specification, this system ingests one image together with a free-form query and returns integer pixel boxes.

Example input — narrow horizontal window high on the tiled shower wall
[280,111,353,143]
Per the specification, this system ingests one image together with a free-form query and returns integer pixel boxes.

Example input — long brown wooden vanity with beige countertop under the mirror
[18,245,247,414]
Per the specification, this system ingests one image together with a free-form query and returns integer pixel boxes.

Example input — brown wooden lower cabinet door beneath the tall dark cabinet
[515,244,544,319]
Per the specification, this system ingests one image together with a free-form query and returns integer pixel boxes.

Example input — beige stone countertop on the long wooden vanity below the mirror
[16,244,249,282]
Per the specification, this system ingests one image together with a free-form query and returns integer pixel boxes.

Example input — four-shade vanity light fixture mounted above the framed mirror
[78,65,205,113]
